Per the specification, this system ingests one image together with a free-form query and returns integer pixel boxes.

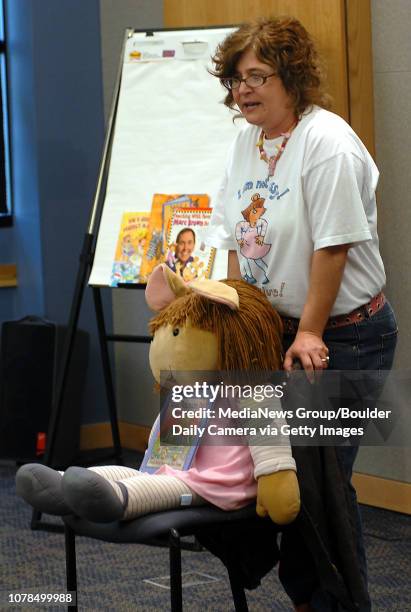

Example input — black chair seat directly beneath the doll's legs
[63,504,265,544]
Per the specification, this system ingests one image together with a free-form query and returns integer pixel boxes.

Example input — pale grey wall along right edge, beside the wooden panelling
[356,0,411,482]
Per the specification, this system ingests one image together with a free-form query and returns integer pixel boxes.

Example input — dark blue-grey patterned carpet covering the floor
[0,466,411,612]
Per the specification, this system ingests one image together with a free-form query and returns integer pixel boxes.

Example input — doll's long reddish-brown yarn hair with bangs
[150,280,282,372]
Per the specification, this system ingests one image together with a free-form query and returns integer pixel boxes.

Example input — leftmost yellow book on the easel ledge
[110,212,150,287]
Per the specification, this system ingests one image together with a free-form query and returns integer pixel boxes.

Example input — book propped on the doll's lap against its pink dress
[139,399,209,473]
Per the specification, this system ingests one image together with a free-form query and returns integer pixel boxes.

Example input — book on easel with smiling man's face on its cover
[165,208,215,282]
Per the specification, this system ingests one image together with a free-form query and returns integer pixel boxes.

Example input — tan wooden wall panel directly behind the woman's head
[164,0,349,120]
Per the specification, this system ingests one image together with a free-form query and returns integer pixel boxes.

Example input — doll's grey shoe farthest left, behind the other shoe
[16,463,71,516]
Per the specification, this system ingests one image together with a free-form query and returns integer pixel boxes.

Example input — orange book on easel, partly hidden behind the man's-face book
[140,193,209,283]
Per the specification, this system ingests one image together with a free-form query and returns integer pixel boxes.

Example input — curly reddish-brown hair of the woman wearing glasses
[211,17,331,117]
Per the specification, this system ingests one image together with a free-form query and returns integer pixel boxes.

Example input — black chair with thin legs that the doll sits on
[64,505,277,612]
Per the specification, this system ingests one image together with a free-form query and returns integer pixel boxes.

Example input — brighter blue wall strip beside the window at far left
[0,0,44,321]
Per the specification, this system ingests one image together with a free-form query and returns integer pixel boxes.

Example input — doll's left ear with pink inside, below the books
[146,264,190,311]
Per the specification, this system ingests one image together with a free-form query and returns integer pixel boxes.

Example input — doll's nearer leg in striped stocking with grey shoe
[63,468,205,523]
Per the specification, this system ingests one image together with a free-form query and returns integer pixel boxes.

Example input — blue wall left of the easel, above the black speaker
[0,0,108,422]
